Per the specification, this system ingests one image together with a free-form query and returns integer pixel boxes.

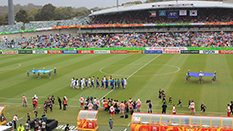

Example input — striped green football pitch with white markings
[0,54,233,130]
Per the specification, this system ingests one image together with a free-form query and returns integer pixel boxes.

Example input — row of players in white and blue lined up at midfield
[70,76,127,90]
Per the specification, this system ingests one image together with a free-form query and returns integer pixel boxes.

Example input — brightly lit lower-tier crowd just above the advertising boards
[1,31,233,49]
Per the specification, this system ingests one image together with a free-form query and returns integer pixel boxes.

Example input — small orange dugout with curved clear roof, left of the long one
[77,110,99,131]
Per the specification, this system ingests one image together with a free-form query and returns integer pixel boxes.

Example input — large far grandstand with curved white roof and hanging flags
[0,1,233,48]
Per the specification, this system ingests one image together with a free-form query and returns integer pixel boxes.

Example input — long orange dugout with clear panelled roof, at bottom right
[131,113,233,131]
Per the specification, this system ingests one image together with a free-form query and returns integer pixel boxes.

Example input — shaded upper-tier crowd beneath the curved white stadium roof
[91,9,233,24]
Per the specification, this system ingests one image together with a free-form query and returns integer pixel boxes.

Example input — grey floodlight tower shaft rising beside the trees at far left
[8,0,15,25]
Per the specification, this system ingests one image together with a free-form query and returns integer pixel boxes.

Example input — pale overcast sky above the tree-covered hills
[0,0,146,9]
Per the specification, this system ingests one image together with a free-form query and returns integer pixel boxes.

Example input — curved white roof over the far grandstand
[89,1,233,16]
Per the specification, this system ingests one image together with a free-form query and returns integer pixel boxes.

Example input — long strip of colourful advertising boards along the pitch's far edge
[0,47,233,54]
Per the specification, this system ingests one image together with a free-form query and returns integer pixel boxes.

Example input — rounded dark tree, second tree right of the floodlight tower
[40,4,56,21]
